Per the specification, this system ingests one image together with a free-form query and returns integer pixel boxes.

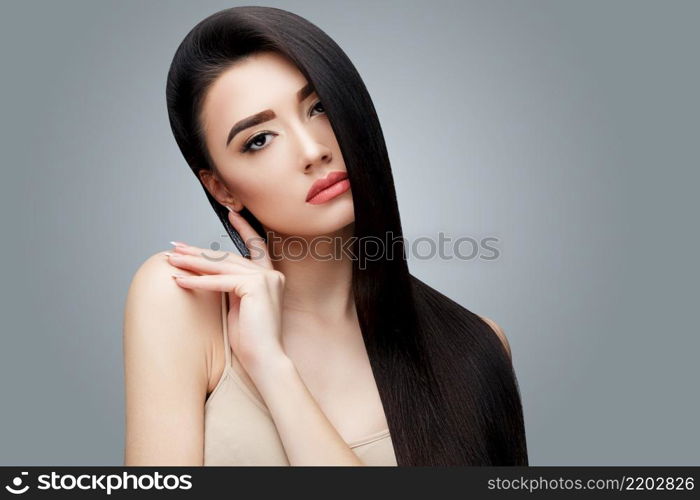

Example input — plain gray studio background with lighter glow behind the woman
[0,0,700,465]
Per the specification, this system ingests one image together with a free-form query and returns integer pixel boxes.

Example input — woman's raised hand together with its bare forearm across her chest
[164,212,364,465]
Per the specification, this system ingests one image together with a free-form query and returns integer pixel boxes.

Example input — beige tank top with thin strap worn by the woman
[204,292,397,466]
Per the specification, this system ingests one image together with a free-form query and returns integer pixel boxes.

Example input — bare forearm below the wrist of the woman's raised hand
[247,356,364,466]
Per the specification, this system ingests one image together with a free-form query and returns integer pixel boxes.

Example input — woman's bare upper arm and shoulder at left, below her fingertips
[123,255,207,466]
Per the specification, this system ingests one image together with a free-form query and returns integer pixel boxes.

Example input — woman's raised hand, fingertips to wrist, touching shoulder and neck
[168,211,286,374]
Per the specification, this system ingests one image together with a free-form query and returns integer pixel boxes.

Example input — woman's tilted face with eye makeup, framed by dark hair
[201,52,355,236]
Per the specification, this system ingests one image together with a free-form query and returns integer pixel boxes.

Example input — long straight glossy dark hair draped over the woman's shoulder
[166,6,528,466]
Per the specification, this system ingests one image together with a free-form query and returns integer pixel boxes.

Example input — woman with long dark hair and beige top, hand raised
[124,7,528,465]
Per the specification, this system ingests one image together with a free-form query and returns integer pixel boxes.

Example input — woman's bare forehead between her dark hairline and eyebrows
[202,52,306,129]
